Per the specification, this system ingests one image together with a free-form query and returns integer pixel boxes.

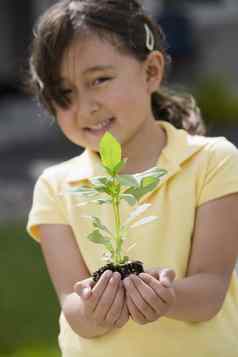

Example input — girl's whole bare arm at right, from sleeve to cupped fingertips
[125,194,238,323]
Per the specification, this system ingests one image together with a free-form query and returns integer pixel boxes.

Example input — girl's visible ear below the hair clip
[144,51,164,94]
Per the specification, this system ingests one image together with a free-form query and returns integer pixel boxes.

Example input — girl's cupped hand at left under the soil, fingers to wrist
[74,270,129,328]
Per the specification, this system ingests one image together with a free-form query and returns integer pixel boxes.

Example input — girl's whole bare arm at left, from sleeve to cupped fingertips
[39,224,126,338]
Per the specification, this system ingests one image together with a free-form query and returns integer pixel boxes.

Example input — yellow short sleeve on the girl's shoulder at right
[198,138,238,206]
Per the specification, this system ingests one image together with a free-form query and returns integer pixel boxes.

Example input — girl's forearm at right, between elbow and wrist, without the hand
[166,273,226,322]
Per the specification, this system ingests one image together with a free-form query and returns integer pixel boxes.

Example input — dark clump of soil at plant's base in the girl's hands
[92,261,144,283]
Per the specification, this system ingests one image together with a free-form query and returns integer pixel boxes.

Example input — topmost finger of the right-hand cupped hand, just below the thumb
[139,273,175,305]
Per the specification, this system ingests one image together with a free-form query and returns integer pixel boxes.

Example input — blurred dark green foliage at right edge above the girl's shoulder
[193,76,238,125]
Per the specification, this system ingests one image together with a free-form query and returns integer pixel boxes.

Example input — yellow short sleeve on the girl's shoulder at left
[27,174,68,241]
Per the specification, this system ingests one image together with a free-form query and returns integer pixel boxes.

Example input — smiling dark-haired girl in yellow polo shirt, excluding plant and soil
[27,0,238,357]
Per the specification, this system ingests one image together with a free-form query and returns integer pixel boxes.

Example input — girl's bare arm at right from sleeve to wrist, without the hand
[167,194,238,321]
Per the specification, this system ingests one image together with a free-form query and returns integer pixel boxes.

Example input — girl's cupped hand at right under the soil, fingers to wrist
[123,269,176,325]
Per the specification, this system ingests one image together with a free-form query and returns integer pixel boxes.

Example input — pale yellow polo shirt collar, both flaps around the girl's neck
[67,121,206,186]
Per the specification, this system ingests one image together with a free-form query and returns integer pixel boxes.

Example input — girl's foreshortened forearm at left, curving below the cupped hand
[62,293,110,338]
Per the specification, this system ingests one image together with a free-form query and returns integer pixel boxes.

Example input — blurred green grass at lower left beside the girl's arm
[0,223,59,357]
